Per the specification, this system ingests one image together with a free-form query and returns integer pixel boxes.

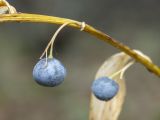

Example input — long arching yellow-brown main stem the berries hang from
[0,13,160,77]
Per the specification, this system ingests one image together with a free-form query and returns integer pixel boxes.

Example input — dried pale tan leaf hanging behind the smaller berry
[89,53,133,120]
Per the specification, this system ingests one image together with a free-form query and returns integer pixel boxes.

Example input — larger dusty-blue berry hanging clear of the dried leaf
[33,58,66,87]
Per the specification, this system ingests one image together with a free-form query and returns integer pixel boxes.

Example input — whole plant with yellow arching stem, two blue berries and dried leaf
[0,0,160,120]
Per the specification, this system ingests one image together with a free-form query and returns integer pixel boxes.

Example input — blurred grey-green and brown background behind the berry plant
[0,0,160,120]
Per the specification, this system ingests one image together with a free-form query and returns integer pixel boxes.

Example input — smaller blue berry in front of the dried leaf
[91,77,119,101]
